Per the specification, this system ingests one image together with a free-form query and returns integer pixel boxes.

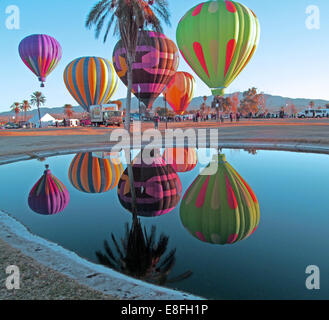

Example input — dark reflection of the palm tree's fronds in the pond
[96,218,192,285]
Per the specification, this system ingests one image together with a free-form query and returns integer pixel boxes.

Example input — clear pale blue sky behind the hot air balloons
[0,0,329,112]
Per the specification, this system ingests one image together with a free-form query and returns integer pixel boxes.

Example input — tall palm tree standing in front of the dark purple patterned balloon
[86,0,170,132]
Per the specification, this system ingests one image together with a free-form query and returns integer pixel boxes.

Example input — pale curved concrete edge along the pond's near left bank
[0,210,202,300]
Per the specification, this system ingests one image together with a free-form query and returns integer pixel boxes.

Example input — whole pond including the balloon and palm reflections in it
[0,149,329,299]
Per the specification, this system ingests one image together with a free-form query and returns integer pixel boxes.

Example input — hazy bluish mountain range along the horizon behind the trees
[0,92,329,117]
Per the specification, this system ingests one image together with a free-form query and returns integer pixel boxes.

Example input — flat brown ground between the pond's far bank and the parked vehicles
[0,119,329,158]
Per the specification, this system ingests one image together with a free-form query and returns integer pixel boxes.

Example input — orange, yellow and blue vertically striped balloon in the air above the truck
[64,57,119,112]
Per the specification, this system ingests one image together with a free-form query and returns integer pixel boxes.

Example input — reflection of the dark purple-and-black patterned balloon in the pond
[118,151,182,217]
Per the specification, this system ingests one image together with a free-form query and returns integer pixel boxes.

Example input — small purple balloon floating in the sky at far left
[18,34,62,87]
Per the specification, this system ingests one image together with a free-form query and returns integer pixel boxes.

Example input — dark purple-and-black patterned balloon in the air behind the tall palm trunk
[113,31,179,108]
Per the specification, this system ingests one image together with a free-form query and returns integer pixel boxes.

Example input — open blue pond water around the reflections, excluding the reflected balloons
[0,150,329,299]
